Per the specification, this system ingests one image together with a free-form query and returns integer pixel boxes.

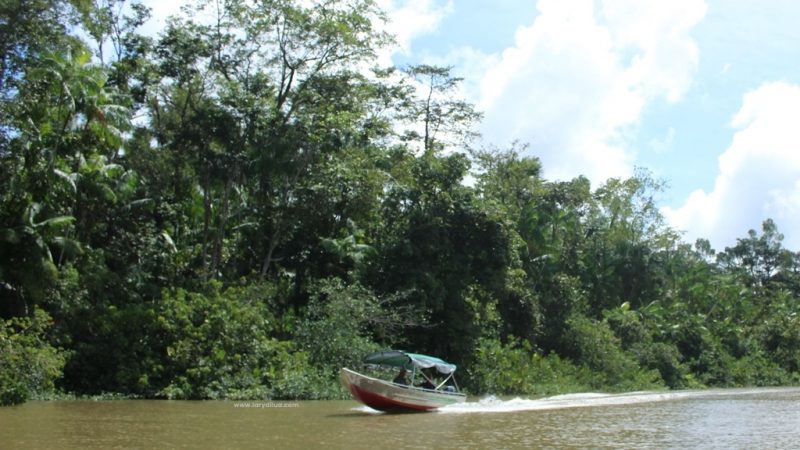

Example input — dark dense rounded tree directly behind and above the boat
[368,153,510,361]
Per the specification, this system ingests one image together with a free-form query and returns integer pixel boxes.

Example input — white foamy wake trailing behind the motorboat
[438,388,800,414]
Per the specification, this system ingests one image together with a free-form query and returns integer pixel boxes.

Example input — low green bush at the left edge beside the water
[0,308,64,406]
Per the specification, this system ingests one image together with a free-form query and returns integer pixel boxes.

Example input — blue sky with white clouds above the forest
[145,0,800,251]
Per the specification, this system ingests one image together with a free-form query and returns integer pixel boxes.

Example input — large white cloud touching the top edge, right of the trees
[478,0,706,182]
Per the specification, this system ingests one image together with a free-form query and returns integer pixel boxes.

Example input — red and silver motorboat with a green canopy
[340,350,467,412]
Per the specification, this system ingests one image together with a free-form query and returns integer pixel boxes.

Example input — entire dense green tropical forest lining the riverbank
[0,0,800,404]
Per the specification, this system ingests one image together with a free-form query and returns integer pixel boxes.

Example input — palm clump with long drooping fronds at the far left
[0,47,128,315]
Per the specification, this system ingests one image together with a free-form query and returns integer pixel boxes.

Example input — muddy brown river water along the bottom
[0,388,800,449]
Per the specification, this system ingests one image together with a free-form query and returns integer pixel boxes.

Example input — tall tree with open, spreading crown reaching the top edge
[142,0,392,277]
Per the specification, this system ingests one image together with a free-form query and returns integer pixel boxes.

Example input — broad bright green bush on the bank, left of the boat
[158,283,284,399]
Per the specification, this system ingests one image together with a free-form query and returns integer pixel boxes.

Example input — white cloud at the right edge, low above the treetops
[663,82,800,250]
